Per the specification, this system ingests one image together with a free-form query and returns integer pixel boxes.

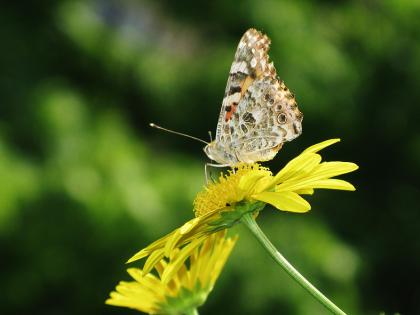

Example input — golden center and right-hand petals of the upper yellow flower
[194,139,358,217]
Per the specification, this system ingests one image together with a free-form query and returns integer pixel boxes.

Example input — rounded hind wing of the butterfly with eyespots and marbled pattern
[230,76,303,163]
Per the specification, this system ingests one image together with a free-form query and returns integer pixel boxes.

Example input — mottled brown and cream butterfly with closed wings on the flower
[204,28,303,167]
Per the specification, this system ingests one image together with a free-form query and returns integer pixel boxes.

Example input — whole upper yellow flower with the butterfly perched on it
[128,139,358,282]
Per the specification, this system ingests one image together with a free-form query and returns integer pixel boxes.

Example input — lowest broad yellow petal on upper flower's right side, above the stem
[252,191,311,212]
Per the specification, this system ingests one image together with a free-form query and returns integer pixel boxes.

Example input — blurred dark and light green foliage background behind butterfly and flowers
[0,0,420,314]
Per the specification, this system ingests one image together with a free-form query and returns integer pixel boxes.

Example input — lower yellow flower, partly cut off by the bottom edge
[106,231,236,315]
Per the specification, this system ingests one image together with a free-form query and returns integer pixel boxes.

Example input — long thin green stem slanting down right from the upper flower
[241,213,346,315]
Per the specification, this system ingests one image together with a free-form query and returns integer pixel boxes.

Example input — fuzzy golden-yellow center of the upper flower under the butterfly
[194,163,272,217]
